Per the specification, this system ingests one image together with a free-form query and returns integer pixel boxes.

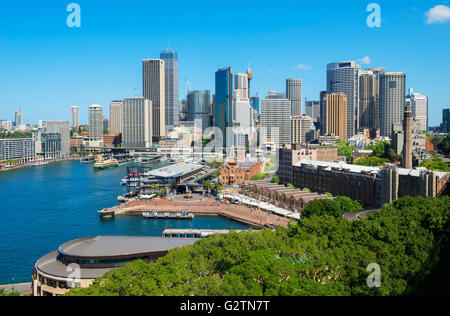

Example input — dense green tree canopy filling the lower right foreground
[69,197,450,296]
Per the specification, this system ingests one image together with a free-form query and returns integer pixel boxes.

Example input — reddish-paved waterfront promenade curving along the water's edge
[99,198,291,228]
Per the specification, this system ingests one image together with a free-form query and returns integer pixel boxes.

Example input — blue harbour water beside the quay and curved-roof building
[0,161,247,284]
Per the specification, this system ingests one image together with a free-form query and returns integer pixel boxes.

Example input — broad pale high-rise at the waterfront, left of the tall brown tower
[122,97,155,148]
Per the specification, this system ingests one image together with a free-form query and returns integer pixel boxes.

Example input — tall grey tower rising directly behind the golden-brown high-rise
[327,61,360,138]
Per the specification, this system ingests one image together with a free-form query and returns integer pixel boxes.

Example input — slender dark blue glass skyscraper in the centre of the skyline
[214,67,233,147]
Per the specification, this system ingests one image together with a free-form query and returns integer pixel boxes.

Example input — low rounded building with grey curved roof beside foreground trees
[32,236,198,296]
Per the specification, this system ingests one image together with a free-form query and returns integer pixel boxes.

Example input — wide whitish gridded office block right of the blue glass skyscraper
[260,97,291,147]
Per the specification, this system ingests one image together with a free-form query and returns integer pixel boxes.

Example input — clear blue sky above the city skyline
[0,0,450,125]
